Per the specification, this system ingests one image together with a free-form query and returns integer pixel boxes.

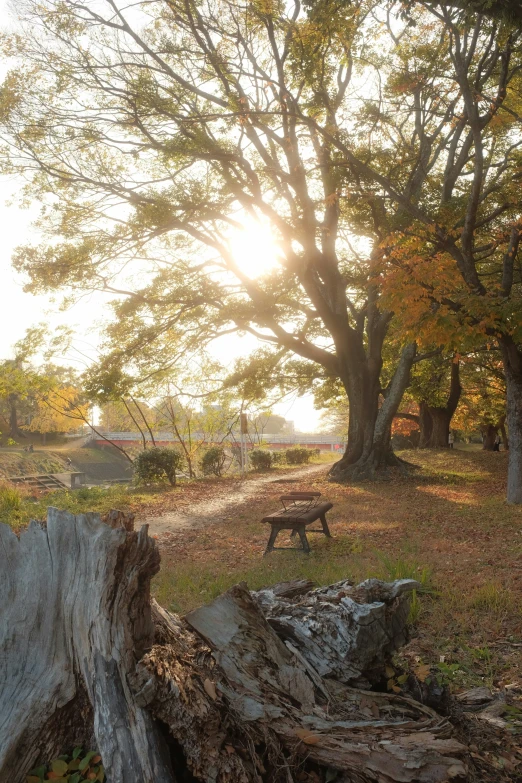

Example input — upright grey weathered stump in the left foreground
[0,508,173,783]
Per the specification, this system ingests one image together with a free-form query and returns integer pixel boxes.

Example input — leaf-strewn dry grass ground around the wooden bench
[155,450,522,687]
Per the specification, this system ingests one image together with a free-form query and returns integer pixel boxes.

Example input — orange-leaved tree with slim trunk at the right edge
[312,3,522,496]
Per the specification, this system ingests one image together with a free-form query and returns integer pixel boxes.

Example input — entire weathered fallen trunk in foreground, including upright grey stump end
[0,509,465,783]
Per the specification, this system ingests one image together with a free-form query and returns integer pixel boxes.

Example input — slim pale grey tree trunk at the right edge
[500,336,522,503]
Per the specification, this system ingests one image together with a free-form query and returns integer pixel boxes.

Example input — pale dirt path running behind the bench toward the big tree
[144,465,329,536]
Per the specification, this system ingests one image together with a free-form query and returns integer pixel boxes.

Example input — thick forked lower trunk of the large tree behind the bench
[329,343,416,481]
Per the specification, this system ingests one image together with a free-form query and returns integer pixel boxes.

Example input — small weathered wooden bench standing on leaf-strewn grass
[261,492,333,555]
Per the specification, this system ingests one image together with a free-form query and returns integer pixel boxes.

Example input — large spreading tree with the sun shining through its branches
[1,0,434,478]
